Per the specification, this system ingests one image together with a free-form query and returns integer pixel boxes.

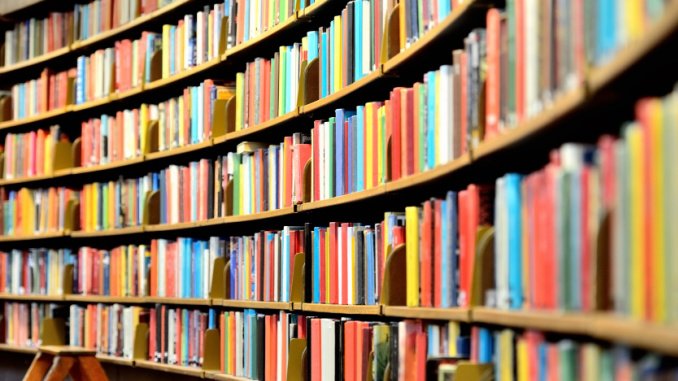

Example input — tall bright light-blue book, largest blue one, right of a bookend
[504,173,523,309]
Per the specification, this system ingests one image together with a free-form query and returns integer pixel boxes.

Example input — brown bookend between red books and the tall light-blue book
[469,226,495,307]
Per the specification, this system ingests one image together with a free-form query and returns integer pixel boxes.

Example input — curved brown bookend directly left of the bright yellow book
[381,244,407,306]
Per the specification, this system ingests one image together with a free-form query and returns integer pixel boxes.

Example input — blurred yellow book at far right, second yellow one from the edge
[625,123,647,319]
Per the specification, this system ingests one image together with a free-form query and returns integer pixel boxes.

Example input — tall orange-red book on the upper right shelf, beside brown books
[485,8,501,138]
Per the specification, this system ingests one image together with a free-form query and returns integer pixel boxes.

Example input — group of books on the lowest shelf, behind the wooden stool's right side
[68,304,143,359]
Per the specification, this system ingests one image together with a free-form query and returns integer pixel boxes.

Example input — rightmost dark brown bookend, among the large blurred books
[591,210,613,311]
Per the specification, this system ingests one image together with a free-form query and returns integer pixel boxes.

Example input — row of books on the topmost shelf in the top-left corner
[4,0,172,66]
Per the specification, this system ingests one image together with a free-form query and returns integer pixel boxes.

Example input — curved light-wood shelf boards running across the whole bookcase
[0,0,678,380]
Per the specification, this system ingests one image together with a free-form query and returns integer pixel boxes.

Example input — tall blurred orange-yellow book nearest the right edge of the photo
[648,99,668,322]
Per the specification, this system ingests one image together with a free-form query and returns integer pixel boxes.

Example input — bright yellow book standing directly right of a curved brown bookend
[405,206,420,307]
